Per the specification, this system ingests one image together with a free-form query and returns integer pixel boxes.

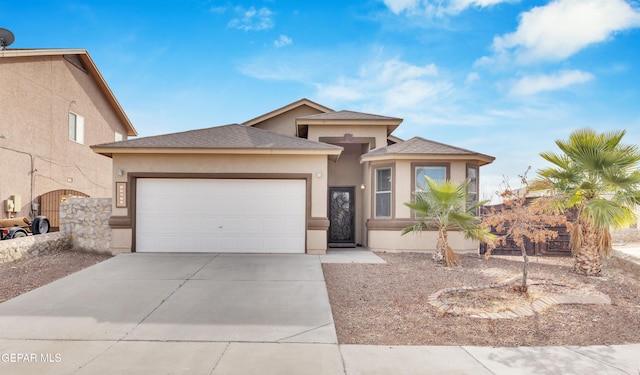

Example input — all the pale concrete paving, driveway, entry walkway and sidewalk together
[0,250,640,375]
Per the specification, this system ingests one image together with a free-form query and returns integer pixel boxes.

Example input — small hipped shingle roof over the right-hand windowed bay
[361,137,495,165]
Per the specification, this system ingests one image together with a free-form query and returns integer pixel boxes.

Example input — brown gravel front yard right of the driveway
[323,253,640,346]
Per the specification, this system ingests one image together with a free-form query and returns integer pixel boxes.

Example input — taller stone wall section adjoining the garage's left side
[60,198,111,254]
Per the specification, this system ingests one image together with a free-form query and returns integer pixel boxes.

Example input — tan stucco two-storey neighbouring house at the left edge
[0,49,136,227]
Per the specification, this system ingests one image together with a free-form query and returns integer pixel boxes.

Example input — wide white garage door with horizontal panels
[136,178,306,253]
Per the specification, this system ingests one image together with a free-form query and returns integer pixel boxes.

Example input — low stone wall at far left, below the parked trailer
[0,232,71,263]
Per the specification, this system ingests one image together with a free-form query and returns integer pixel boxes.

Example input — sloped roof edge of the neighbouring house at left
[0,49,138,136]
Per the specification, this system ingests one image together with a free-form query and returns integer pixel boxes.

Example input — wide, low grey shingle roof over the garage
[91,124,342,160]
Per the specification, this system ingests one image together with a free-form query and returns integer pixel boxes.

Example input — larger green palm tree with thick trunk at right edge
[538,128,640,275]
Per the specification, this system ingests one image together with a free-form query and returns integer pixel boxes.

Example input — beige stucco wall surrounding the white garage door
[112,154,327,254]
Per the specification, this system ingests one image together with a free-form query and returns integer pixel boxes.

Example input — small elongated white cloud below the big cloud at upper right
[511,70,594,95]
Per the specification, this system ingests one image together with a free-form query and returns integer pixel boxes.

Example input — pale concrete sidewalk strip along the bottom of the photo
[0,340,640,375]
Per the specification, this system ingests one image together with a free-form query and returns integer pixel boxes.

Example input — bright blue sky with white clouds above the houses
[0,0,640,198]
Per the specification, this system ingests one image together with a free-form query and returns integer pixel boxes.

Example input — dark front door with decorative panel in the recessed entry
[329,187,355,247]
